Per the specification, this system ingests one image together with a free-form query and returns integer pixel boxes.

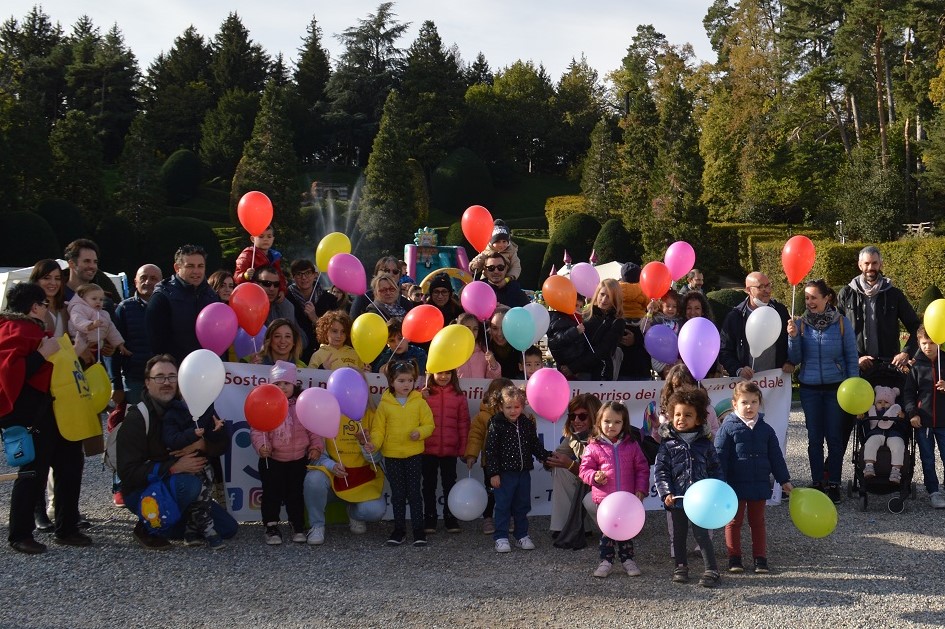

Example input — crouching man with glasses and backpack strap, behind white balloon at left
[115,354,237,550]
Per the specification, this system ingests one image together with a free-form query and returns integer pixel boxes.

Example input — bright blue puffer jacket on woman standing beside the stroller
[788,315,860,385]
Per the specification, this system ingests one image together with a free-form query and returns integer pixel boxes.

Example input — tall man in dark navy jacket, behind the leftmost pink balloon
[145,245,220,361]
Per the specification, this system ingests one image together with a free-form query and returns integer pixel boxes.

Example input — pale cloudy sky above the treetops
[0,0,714,81]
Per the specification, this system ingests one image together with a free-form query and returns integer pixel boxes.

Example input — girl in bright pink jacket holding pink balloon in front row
[578,402,650,579]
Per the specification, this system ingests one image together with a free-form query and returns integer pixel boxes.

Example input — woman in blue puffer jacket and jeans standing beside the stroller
[787,280,859,504]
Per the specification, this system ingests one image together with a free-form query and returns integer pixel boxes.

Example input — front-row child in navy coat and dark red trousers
[715,380,793,574]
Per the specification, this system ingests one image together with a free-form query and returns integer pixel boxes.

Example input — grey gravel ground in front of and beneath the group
[0,412,945,628]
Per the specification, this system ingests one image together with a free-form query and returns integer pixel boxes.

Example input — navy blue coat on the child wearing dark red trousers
[715,413,791,500]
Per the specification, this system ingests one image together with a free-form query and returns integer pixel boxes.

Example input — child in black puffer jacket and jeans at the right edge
[902,325,945,509]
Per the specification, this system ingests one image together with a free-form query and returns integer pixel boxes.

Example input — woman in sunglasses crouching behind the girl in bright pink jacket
[545,393,601,537]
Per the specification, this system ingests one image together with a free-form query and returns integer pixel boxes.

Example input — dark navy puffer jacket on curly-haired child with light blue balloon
[654,424,725,509]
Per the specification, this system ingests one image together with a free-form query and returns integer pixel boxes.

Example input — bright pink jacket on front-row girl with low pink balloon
[578,435,650,504]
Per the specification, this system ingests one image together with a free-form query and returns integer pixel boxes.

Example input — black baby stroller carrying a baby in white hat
[847,362,916,513]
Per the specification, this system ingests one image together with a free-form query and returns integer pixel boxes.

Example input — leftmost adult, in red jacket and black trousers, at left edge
[0,282,92,555]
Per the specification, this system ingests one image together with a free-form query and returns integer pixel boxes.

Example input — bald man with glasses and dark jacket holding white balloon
[719,271,794,380]
